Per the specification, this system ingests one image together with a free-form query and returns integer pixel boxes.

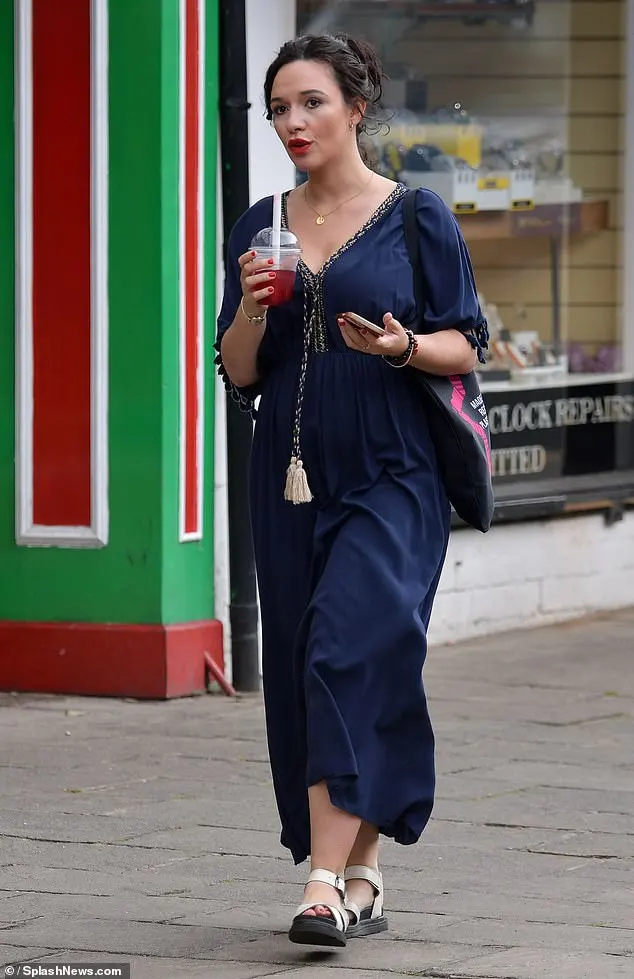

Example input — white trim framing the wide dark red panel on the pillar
[15,0,109,548]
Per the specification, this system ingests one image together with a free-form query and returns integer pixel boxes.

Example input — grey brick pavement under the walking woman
[0,610,634,979]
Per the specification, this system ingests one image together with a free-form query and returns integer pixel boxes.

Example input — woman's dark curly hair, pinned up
[264,34,385,139]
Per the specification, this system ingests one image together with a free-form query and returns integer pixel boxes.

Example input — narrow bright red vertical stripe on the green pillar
[184,0,202,534]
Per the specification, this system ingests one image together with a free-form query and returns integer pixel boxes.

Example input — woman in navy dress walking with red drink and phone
[216,35,486,946]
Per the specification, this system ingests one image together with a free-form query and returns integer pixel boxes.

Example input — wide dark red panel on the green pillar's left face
[33,0,91,526]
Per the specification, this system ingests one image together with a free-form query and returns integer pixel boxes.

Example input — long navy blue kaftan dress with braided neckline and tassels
[216,185,484,863]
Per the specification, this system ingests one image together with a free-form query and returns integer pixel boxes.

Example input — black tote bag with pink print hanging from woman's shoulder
[403,190,495,533]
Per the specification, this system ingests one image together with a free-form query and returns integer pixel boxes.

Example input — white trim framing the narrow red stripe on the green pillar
[178,0,205,543]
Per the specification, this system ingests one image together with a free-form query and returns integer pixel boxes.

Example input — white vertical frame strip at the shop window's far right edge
[621,0,634,373]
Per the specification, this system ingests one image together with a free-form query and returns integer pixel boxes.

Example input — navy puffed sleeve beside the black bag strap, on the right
[416,189,489,363]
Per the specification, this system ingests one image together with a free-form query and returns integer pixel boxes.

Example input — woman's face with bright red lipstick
[271,61,361,171]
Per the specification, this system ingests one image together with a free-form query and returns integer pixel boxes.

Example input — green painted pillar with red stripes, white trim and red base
[0,0,223,697]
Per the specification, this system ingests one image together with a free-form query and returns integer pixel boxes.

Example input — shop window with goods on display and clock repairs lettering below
[297,0,634,506]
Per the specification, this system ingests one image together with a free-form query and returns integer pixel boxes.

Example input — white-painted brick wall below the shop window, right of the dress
[429,511,634,644]
